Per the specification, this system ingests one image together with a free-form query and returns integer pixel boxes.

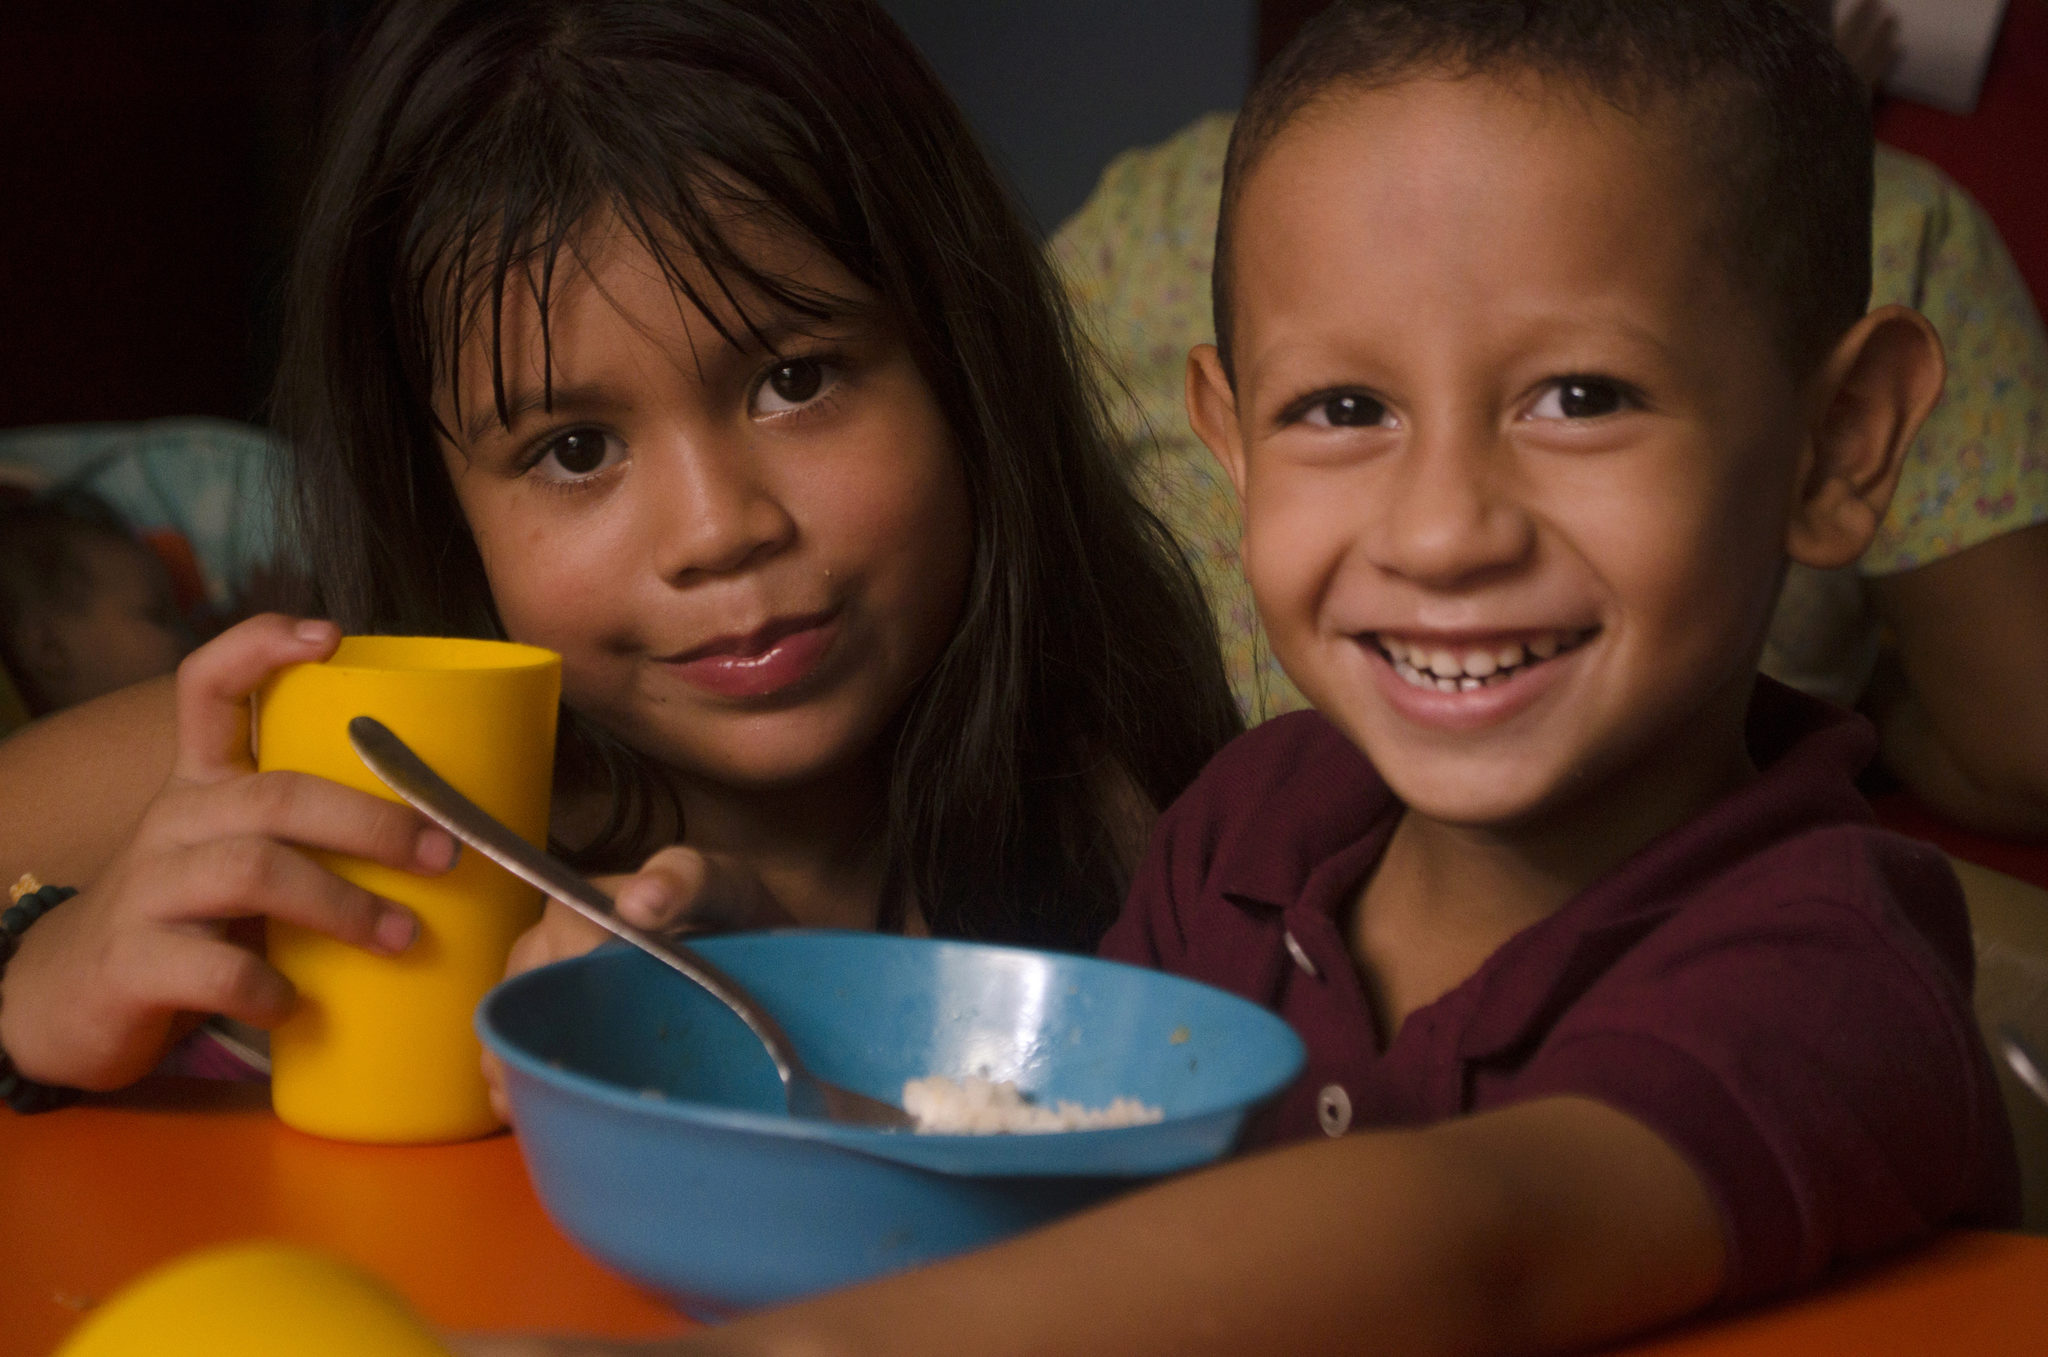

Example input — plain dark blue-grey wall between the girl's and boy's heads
[883,0,1257,231]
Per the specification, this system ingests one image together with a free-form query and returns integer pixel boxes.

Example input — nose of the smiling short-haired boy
[1370,428,1536,589]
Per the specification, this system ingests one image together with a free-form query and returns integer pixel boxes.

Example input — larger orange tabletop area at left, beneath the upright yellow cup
[0,1079,690,1357]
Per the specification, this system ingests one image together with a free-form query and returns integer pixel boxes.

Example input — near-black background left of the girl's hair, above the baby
[0,0,365,428]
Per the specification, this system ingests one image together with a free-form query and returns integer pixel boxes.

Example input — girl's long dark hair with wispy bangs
[266,0,1239,946]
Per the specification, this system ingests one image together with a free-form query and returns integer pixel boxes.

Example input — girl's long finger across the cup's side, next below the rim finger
[156,772,459,876]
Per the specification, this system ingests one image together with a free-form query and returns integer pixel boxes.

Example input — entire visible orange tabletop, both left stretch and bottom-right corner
[0,1081,2048,1357]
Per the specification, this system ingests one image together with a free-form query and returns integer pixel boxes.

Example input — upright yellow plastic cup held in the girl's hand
[256,637,561,1144]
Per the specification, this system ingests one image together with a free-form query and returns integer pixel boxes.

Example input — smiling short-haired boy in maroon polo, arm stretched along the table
[475,0,2017,1357]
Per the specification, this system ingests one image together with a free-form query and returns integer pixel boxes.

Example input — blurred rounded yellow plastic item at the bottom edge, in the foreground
[57,1242,449,1357]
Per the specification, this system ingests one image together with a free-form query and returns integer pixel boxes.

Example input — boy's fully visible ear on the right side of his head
[1786,307,1948,569]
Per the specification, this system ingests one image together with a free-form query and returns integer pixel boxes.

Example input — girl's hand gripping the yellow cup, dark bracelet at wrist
[0,614,455,1089]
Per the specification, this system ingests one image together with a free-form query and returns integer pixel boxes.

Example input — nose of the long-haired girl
[641,440,797,583]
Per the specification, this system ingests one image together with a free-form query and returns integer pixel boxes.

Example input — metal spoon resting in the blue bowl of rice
[348,716,911,1128]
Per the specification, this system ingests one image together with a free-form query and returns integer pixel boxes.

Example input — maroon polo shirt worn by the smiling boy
[1102,680,2019,1300]
